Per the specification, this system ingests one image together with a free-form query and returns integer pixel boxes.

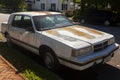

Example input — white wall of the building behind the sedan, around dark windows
[29,0,74,11]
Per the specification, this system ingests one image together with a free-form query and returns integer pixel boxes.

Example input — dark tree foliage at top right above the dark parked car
[73,0,120,20]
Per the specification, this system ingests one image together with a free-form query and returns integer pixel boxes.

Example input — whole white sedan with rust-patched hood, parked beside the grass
[1,12,119,70]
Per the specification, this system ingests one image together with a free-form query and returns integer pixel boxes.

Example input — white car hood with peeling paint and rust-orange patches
[42,25,113,48]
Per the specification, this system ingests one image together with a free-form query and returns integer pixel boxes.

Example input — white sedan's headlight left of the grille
[71,46,92,57]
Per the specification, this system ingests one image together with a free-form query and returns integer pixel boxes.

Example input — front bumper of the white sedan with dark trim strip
[59,43,119,70]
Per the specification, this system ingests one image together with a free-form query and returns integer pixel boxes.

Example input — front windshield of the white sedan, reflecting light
[33,15,73,31]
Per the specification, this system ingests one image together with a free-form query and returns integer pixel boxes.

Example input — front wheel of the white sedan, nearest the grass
[43,50,59,71]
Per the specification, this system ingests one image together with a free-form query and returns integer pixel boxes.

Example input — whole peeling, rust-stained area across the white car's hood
[46,26,104,41]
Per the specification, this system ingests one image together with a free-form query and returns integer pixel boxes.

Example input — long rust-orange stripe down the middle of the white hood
[62,27,95,39]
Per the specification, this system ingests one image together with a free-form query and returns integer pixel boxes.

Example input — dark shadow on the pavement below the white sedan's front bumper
[57,64,120,80]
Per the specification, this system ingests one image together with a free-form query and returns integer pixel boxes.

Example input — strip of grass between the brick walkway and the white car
[0,35,58,80]
